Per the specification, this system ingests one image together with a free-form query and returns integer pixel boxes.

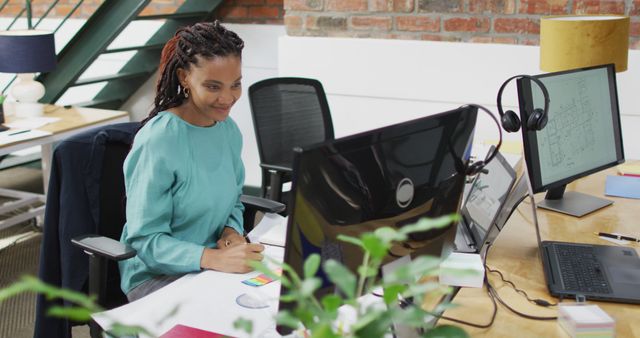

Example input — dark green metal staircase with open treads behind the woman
[0,0,222,109]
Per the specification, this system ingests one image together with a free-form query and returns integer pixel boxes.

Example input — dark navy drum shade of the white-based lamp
[0,30,56,73]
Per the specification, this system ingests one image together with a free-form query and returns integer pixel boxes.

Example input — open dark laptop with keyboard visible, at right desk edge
[529,176,640,304]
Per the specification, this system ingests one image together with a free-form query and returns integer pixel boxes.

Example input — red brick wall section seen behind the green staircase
[0,0,284,24]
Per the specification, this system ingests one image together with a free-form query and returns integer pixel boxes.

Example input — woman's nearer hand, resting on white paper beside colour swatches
[200,242,264,273]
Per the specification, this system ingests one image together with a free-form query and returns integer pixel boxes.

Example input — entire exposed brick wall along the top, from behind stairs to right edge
[0,0,640,49]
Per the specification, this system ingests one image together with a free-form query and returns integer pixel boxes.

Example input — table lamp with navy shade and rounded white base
[0,29,56,117]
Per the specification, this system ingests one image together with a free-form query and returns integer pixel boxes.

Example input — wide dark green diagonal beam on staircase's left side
[38,0,150,103]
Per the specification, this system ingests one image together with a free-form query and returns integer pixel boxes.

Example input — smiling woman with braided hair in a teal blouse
[120,21,264,301]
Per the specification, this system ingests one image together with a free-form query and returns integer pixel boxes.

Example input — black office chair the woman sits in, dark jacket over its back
[36,122,284,337]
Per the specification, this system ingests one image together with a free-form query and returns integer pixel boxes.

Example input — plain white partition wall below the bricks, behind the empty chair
[278,36,640,159]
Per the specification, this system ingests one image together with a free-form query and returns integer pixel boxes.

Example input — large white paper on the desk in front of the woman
[92,246,284,337]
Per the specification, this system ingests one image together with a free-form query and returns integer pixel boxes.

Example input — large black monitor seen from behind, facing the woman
[279,106,477,332]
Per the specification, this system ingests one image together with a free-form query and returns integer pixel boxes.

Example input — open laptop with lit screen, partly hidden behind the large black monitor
[455,146,516,256]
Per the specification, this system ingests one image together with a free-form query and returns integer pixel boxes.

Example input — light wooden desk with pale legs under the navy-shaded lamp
[0,105,129,230]
